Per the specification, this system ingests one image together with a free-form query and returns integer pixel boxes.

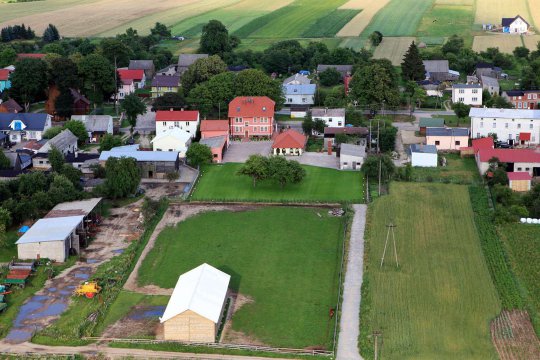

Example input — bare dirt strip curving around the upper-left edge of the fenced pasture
[124,204,254,295]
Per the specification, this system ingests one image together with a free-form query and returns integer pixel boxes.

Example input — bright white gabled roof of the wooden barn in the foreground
[159,264,231,323]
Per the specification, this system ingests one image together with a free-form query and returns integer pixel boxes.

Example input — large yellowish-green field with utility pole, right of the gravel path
[361,183,500,359]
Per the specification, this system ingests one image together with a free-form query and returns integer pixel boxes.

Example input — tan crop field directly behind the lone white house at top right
[474,0,532,25]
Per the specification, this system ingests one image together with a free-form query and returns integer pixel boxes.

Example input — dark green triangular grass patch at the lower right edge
[498,224,540,335]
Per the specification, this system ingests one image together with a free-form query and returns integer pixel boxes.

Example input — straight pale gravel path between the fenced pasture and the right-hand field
[337,205,367,360]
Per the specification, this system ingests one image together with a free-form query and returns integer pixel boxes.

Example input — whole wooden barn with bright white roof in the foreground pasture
[159,264,231,342]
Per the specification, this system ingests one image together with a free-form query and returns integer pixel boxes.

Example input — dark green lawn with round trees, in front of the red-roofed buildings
[192,163,364,203]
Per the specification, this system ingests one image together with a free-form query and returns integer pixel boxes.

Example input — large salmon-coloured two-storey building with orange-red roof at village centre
[229,96,276,139]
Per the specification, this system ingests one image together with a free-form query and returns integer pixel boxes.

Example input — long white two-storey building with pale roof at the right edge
[469,108,540,145]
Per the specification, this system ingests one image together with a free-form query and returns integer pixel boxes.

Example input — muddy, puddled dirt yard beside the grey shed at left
[0,201,141,349]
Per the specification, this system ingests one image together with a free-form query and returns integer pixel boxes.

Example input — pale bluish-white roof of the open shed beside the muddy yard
[16,215,84,244]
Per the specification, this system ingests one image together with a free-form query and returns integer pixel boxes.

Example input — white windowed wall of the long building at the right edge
[471,117,540,144]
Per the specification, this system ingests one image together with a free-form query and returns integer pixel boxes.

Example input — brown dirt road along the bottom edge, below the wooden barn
[0,342,292,360]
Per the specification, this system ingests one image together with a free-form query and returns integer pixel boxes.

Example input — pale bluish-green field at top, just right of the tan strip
[362,0,434,37]
